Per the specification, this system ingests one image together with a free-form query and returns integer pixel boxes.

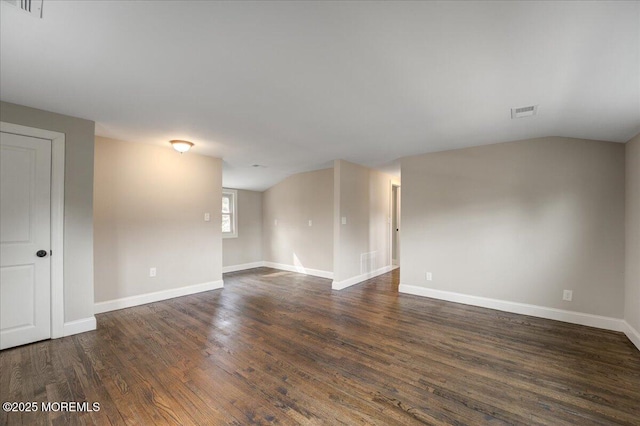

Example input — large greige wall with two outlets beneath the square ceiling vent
[400,137,625,318]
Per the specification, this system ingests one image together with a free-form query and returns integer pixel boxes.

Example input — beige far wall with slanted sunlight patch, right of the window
[262,169,333,272]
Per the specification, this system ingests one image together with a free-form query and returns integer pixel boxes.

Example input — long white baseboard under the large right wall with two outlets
[398,284,625,331]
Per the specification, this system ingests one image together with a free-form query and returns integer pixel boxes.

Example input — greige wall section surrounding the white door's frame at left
[0,102,95,322]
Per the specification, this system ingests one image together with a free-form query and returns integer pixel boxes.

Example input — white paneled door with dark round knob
[0,132,51,349]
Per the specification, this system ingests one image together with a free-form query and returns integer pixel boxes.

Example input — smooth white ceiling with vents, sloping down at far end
[0,0,640,190]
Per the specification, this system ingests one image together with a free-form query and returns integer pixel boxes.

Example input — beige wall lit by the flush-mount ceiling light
[94,137,222,302]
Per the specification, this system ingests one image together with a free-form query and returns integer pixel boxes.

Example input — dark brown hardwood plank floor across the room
[0,268,640,425]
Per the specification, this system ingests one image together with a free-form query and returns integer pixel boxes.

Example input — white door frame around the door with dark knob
[0,122,65,339]
